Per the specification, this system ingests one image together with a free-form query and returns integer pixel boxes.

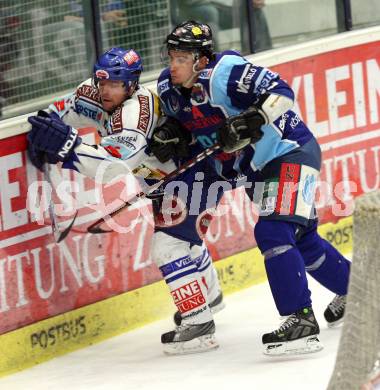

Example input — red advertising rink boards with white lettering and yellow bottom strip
[0,25,380,376]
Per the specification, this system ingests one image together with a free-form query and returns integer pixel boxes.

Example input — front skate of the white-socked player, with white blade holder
[161,320,219,355]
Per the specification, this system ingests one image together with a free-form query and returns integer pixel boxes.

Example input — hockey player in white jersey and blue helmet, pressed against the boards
[28,48,224,354]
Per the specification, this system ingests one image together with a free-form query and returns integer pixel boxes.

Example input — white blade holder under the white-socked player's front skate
[163,334,219,355]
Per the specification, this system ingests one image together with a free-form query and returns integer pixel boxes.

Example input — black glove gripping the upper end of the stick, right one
[218,107,267,153]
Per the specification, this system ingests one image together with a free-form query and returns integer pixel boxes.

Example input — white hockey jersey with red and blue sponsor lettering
[49,79,176,183]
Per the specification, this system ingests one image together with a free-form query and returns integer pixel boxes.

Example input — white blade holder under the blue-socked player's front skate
[263,335,323,356]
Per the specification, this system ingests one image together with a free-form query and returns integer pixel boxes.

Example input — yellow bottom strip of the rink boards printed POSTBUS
[0,217,352,376]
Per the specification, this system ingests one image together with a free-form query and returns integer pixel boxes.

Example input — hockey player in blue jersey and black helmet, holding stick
[153,21,350,355]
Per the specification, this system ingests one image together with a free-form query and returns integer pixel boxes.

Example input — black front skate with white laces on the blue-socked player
[262,307,323,356]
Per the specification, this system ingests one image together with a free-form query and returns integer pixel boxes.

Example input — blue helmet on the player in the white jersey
[94,47,143,96]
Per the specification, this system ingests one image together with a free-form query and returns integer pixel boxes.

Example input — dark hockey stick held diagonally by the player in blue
[87,142,220,234]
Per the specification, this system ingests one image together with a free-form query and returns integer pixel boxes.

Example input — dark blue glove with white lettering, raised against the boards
[27,115,82,161]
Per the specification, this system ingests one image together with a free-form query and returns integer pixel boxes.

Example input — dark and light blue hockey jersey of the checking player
[157,51,313,179]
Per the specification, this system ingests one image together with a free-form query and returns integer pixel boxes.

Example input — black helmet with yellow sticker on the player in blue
[165,20,213,58]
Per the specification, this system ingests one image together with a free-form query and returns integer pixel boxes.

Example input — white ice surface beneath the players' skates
[0,280,341,390]
